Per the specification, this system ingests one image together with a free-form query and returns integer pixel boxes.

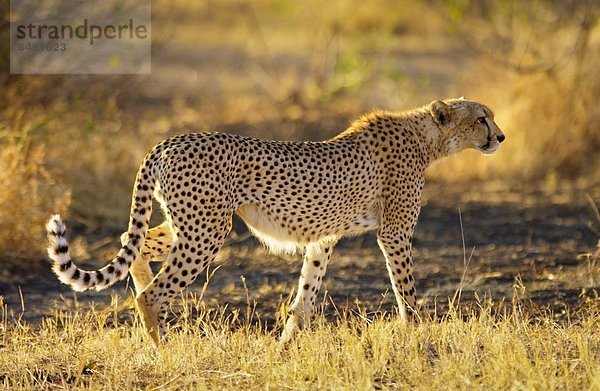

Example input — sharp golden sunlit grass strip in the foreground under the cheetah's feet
[0,296,600,390]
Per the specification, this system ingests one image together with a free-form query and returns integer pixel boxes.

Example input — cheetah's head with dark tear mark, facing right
[429,98,504,155]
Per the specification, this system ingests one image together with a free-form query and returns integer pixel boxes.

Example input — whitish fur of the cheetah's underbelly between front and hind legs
[237,203,378,253]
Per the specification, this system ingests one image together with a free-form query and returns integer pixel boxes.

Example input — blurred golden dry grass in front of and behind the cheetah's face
[431,0,600,186]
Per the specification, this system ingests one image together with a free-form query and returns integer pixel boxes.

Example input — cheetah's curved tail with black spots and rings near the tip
[46,165,154,292]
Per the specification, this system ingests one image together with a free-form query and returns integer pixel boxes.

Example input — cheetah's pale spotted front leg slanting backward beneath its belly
[279,243,335,344]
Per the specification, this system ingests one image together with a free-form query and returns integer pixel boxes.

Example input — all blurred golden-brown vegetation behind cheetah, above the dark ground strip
[0,0,600,259]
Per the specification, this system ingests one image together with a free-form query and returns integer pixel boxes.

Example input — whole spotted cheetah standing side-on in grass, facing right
[46,98,505,343]
